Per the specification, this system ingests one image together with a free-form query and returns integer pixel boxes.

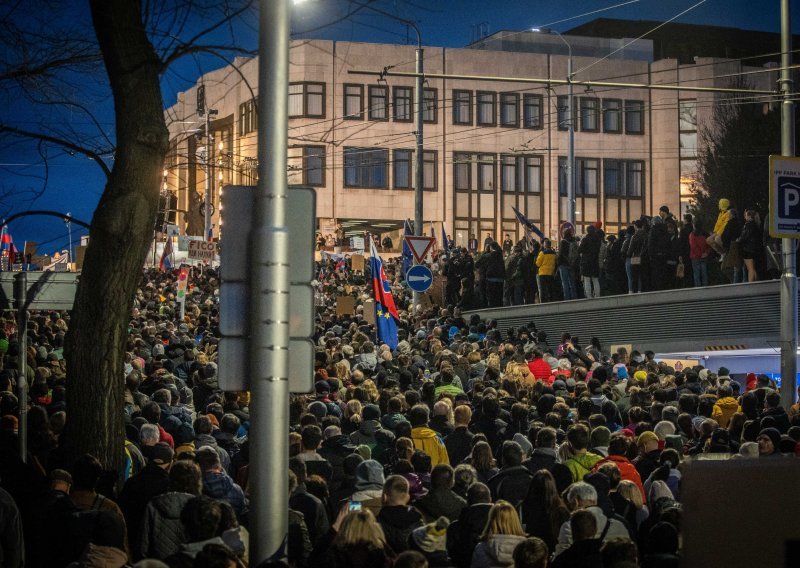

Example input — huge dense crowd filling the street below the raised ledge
[0,232,800,568]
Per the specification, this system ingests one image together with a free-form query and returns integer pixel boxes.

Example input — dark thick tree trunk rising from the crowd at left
[65,0,168,471]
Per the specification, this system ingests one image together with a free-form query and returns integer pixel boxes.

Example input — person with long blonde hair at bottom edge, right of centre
[470,500,527,568]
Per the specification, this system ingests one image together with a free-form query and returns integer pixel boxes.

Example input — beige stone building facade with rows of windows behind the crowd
[164,36,776,246]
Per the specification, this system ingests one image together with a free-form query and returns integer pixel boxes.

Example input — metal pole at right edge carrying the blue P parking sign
[780,0,797,410]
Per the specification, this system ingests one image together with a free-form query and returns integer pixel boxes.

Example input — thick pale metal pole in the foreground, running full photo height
[249,0,290,566]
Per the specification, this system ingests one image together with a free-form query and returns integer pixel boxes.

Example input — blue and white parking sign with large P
[769,156,800,239]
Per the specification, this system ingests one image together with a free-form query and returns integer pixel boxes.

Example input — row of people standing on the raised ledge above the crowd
[440,199,780,309]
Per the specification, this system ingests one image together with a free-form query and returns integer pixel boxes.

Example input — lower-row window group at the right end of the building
[558,157,644,198]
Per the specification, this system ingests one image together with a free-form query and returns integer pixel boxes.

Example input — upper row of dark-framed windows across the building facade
[282,83,644,134]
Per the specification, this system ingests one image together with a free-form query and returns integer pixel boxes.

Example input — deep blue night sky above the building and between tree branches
[0,0,800,253]
